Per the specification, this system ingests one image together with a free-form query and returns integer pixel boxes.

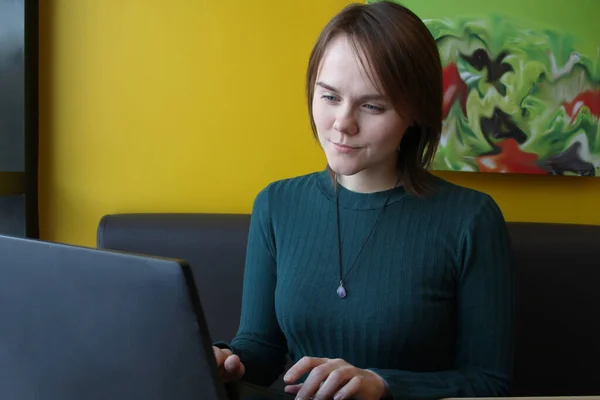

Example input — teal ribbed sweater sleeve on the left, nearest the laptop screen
[215,187,287,386]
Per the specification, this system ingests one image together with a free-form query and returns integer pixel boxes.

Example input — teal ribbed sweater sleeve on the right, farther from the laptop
[371,196,514,400]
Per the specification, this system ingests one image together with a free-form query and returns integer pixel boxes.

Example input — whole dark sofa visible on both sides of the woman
[97,214,600,396]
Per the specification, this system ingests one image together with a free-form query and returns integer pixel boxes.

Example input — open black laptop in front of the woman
[0,235,293,400]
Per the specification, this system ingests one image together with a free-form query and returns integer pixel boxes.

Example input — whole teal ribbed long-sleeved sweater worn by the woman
[218,171,514,399]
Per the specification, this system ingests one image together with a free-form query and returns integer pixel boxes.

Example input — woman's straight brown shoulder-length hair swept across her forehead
[306,1,443,197]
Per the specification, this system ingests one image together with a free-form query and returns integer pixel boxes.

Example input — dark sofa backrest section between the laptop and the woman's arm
[97,214,250,341]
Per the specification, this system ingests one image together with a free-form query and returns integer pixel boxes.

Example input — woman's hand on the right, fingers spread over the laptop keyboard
[283,357,386,400]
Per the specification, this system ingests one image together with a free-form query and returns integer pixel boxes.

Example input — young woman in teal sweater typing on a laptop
[214,2,514,400]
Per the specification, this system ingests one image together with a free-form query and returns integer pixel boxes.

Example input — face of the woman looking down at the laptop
[312,35,408,182]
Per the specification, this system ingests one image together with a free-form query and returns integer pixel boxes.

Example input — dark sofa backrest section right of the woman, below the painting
[508,223,600,396]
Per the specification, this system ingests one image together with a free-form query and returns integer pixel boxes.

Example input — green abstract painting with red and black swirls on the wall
[368,0,600,176]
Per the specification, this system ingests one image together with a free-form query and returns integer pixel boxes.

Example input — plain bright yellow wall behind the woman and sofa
[40,0,600,245]
